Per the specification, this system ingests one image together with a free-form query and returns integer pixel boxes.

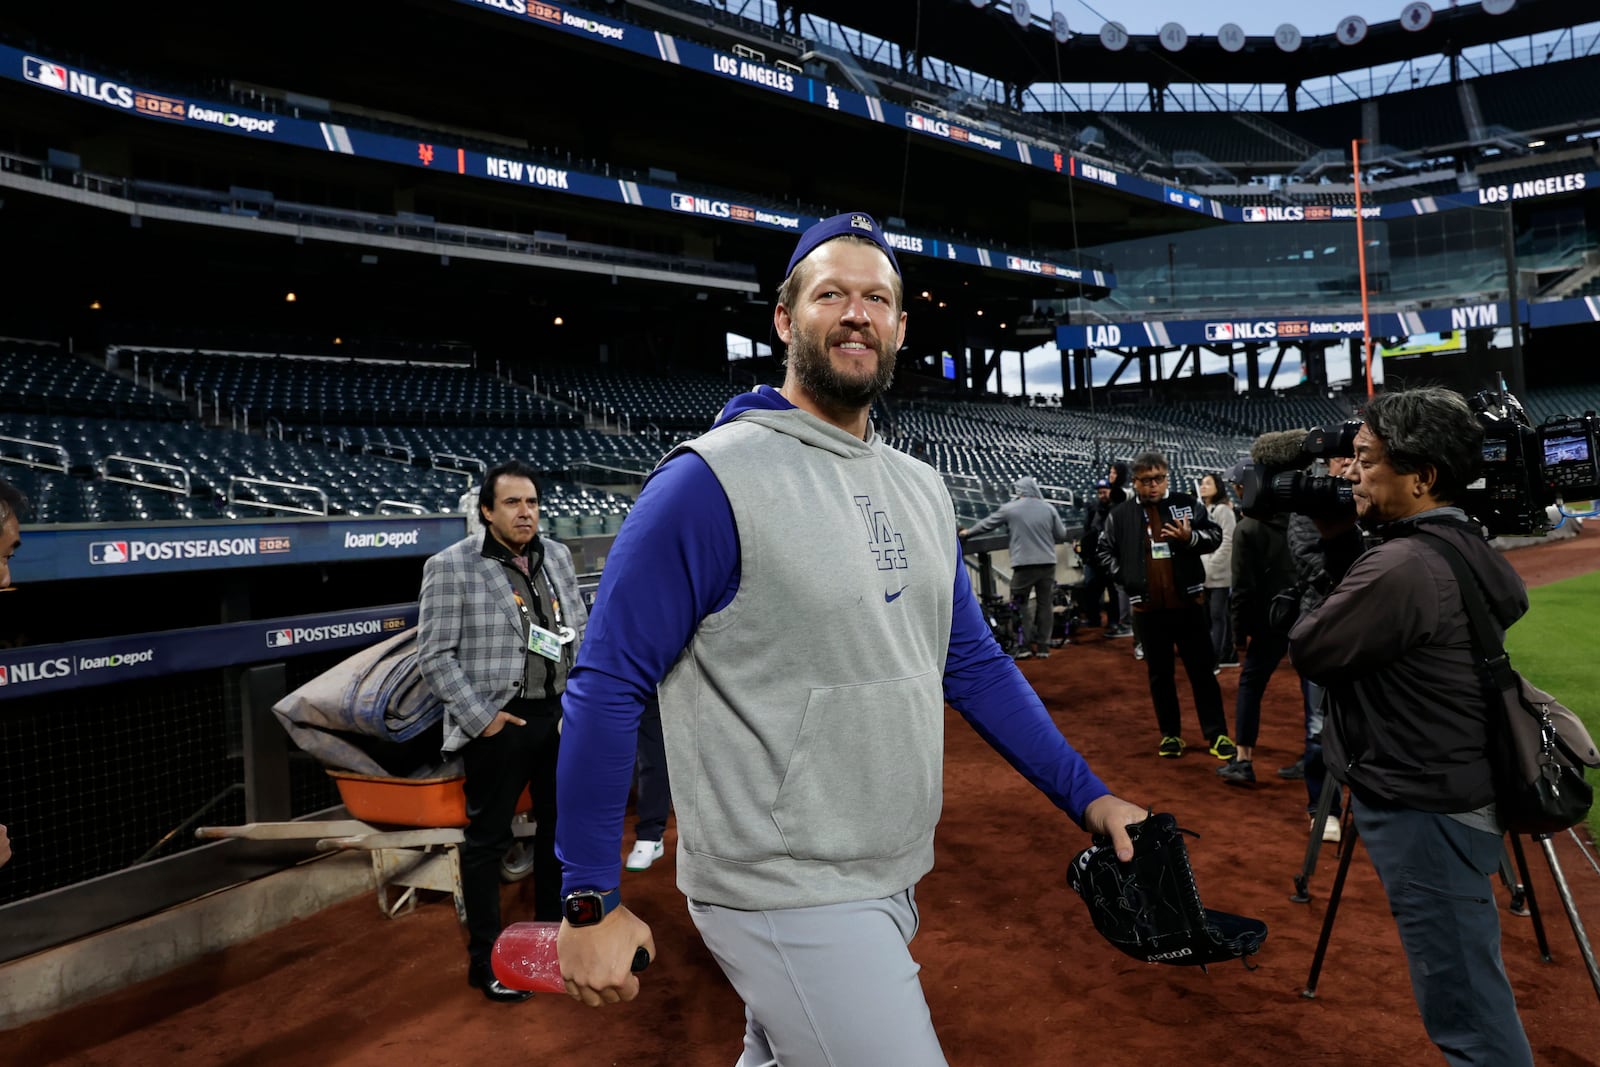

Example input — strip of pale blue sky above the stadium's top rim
[1056,0,1477,37]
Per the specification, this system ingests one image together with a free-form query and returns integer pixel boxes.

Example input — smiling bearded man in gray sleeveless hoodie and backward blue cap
[557,213,1146,1067]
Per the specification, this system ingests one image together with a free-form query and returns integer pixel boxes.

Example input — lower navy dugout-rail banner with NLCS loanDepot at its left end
[0,607,416,701]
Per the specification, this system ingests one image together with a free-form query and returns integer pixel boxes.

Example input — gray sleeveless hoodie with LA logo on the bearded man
[659,410,957,910]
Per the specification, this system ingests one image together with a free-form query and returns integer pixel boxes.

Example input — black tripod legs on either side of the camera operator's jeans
[1290,779,1600,1000]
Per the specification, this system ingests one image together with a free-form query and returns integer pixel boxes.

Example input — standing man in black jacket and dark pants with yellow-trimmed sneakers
[1099,451,1235,761]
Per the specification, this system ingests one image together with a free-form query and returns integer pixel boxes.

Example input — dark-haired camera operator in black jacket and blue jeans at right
[1290,389,1533,1067]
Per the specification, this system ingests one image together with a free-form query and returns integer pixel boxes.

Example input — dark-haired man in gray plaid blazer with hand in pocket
[418,461,589,1001]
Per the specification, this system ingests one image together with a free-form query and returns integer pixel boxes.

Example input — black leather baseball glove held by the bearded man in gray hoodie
[1067,813,1267,969]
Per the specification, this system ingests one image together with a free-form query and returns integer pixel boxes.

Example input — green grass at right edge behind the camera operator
[1506,573,1600,840]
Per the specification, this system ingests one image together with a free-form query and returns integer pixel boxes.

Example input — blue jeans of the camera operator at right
[1350,800,1533,1067]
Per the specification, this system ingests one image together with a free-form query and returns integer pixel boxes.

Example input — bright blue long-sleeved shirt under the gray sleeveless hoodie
[555,387,1110,893]
